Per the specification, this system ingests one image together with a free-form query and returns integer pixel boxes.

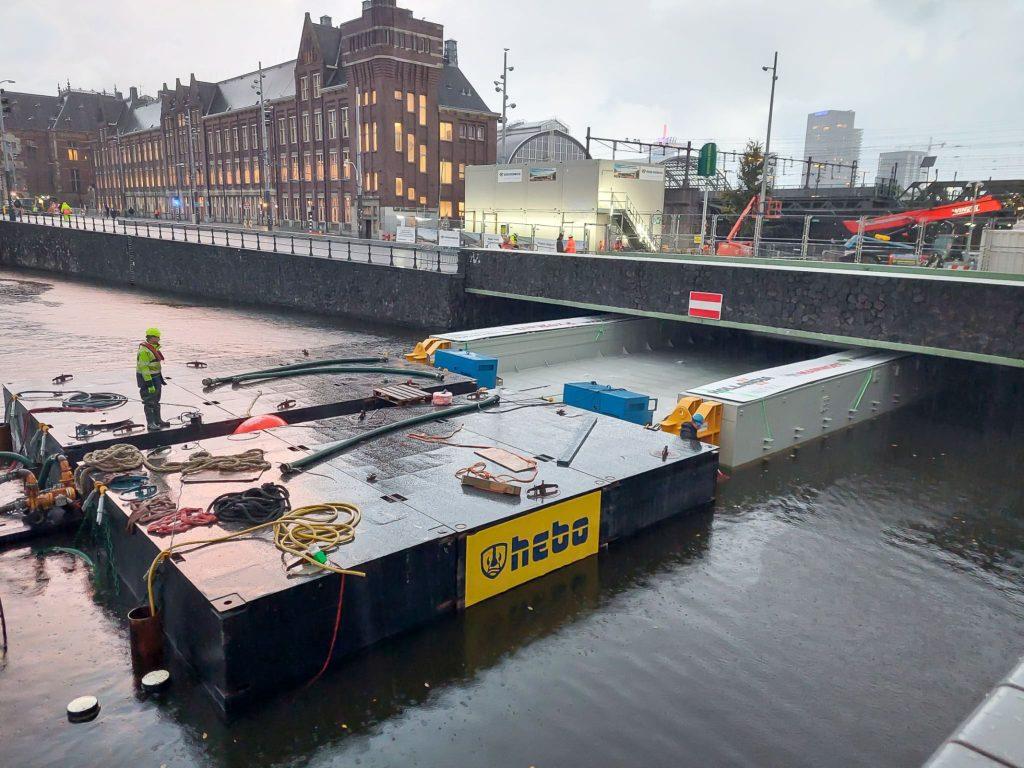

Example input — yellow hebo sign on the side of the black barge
[465,490,601,606]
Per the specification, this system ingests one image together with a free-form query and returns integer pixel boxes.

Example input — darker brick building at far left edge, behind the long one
[4,85,124,207]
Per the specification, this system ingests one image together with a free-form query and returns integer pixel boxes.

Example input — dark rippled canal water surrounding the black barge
[0,271,1024,768]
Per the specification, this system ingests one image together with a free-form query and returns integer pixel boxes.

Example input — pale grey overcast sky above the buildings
[8,0,1024,183]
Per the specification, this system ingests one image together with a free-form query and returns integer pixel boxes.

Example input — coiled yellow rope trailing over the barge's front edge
[145,502,366,616]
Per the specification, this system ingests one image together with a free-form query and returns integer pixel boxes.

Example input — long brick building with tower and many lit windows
[95,0,498,233]
